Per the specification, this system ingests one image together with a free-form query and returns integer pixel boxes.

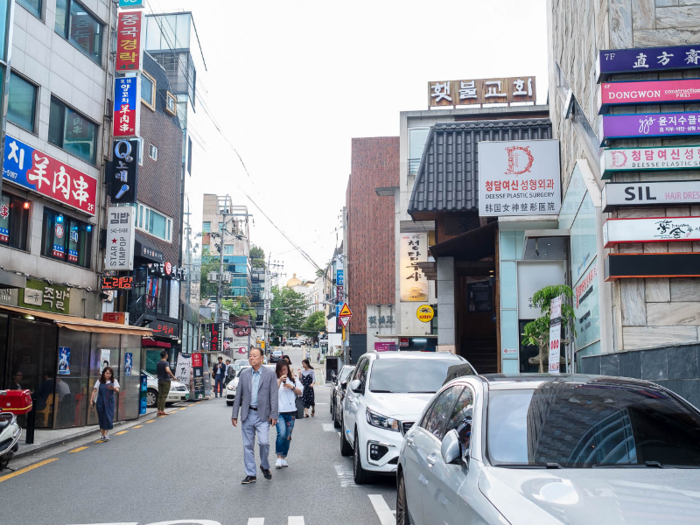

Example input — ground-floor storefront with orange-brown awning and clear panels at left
[0,305,152,429]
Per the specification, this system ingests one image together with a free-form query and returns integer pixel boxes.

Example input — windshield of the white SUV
[369,357,457,394]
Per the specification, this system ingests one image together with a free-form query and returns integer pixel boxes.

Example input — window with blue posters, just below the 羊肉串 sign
[41,208,92,268]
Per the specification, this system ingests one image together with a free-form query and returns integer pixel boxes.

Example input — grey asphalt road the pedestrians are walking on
[0,349,396,525]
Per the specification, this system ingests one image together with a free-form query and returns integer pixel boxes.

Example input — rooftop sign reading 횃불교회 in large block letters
[428,76,536,108]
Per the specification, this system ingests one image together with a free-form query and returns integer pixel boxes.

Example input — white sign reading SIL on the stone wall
[602,180,700,212]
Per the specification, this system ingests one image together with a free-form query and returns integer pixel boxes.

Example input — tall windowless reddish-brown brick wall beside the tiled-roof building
[345,137,399,336]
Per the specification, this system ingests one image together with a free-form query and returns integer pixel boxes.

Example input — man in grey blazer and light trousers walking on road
[231,348,279,485]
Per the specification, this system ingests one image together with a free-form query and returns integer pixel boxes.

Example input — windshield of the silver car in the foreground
[487,379,700,468]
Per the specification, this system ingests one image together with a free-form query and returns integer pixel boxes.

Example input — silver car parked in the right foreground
[396,374,700,525]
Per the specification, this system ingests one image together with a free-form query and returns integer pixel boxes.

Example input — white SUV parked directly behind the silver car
[340,351,476,484]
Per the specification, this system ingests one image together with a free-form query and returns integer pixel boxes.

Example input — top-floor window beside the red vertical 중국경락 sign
[54,0,102,64]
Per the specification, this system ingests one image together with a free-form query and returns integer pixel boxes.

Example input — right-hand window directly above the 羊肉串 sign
[49,97,97,164]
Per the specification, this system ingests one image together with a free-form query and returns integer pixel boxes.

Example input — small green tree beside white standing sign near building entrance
[522,284,576,373]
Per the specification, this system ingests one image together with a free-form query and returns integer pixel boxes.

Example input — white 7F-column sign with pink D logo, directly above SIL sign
[600,146,700,180]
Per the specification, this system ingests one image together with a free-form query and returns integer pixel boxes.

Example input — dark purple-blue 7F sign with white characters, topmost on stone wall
[596,44,700,80]
